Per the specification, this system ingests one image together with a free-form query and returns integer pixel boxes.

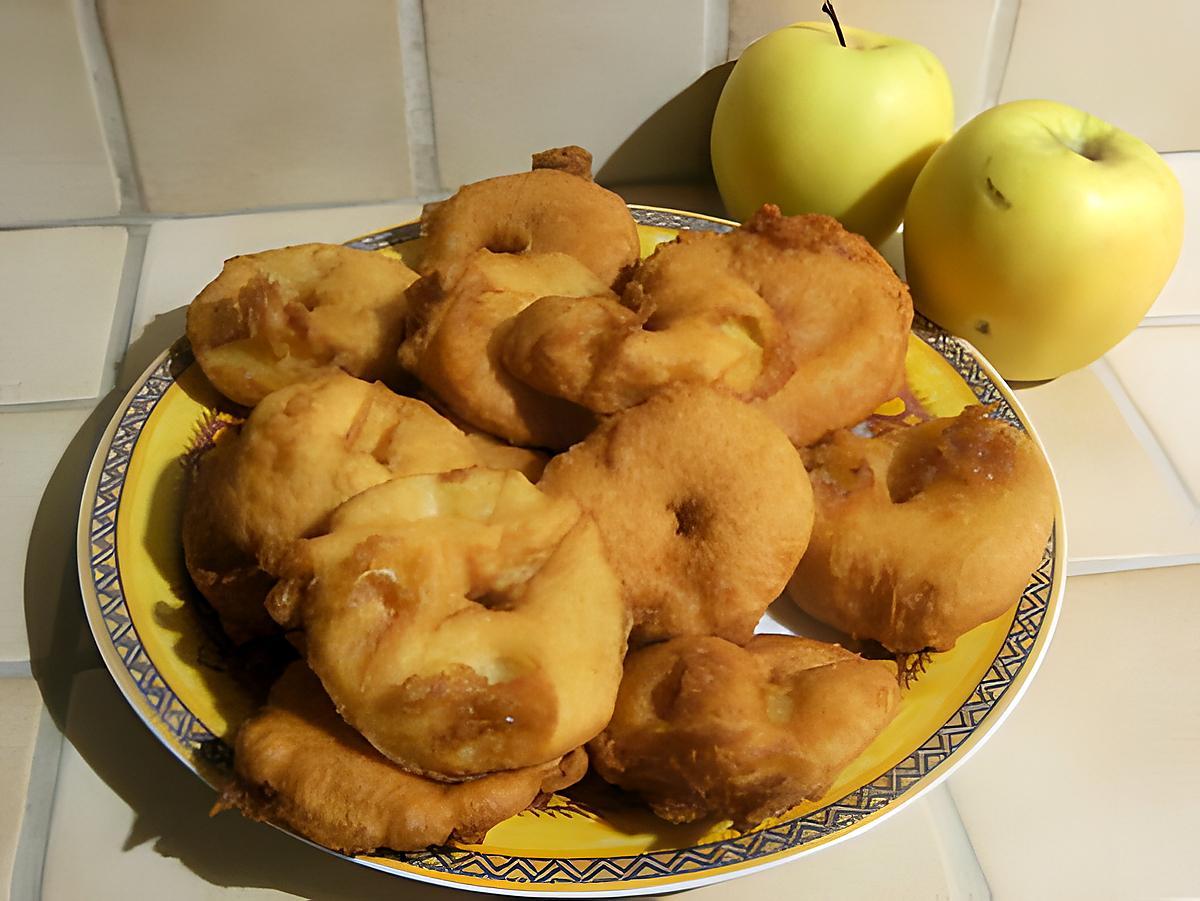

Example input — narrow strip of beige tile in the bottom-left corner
[0,678,42,897]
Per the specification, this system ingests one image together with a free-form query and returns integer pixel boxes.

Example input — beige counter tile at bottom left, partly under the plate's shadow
[42,669,487,901]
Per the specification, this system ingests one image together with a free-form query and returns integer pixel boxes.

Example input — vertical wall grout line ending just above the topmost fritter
[396,0,442,194]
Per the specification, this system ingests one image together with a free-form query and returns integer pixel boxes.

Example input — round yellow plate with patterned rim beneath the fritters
[78,208,1066,896]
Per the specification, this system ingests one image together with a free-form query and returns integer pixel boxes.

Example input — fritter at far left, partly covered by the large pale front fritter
[182,371,482,644]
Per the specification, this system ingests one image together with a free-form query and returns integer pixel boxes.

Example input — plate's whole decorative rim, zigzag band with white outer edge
[77,204,1067,897]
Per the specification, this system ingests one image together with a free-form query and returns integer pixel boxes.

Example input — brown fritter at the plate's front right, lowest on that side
[588,635,899,829]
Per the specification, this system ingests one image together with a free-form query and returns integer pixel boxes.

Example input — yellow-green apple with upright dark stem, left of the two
[712,22,954,244]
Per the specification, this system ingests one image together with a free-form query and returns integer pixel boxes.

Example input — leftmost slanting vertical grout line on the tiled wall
[73,0,145,214]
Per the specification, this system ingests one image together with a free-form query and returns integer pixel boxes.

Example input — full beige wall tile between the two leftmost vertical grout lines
[100,0,412,212]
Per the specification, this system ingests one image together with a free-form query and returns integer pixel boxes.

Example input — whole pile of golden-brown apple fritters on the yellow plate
[184,148,1049,852]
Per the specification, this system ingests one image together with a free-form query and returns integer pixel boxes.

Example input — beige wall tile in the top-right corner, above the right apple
[1000,0,1200,151]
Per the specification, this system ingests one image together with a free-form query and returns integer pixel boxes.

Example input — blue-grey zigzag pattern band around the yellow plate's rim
[82,208,1057,887]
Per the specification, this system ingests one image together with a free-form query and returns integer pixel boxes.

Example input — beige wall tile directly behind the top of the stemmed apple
[730,0,1002,124]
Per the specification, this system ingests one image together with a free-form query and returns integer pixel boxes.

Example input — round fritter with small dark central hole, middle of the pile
[539,386,812,645]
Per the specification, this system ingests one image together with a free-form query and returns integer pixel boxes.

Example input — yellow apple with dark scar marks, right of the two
[904,101,1183,380]
